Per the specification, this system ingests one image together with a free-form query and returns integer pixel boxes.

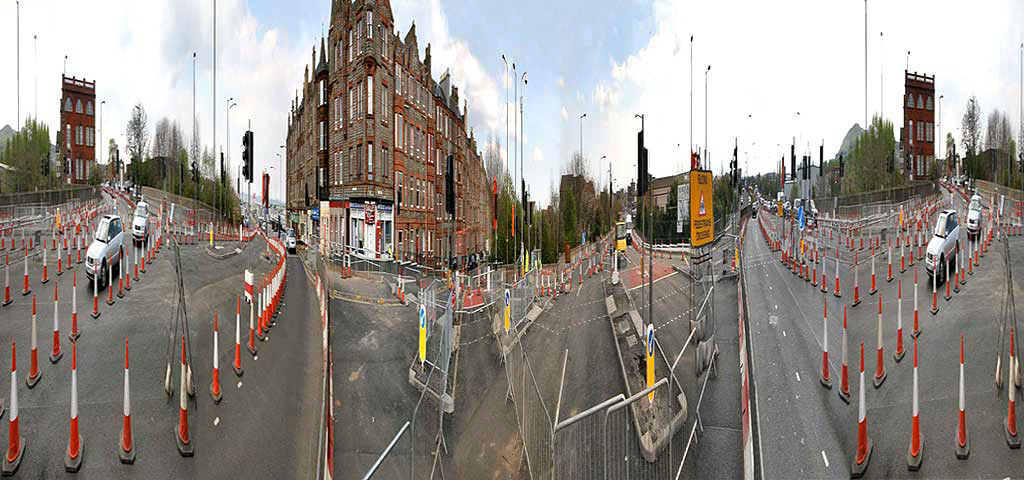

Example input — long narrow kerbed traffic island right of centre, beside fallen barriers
[605,278,688,463]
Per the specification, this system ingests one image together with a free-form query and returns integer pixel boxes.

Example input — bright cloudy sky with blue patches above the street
[0,0,1024,202]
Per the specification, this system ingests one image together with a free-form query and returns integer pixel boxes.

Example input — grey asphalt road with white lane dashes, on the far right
[743,190,1024,478]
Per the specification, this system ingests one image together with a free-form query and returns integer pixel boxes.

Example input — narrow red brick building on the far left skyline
[57,76,97,183]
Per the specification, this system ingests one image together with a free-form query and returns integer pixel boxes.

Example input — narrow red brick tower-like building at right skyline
[901,71,935,180]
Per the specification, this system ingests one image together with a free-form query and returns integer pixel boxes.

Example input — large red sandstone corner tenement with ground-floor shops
[286,0,492,265]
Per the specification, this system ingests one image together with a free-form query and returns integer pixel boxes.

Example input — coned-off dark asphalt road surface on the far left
[0,192,322,478]
